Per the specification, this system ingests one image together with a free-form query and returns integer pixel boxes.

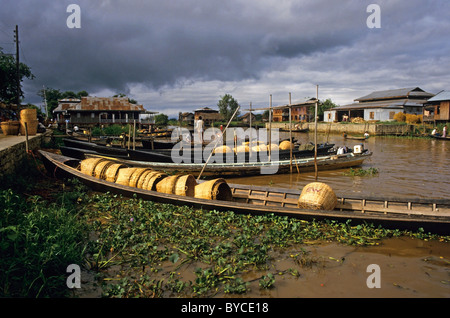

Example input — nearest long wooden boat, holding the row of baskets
[39,150,450,234]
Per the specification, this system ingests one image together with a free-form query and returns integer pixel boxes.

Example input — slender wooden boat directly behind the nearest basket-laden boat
[86,151,372,177]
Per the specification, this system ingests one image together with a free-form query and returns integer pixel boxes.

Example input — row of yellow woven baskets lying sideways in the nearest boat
[79,158,232,200]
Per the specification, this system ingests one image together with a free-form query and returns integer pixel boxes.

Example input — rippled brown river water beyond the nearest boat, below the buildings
[228,133,450,199]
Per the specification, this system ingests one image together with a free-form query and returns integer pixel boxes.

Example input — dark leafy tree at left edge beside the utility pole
[0,50,34,104]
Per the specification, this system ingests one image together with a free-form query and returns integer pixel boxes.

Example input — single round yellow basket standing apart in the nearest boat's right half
[298,182,337,210]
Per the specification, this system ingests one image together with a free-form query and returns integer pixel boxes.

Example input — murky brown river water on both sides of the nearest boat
[74,134,450,298]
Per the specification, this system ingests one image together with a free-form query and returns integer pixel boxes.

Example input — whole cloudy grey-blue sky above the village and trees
[0,0,450,117]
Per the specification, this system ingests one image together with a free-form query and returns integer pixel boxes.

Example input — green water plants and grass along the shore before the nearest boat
[0,155,450,297]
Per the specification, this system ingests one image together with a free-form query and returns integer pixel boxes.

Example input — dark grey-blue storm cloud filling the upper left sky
[2,1,368,95]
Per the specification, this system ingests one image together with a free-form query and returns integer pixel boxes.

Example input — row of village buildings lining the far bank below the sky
[3,87,450,132]
